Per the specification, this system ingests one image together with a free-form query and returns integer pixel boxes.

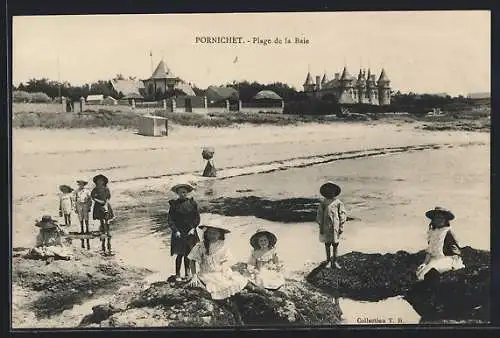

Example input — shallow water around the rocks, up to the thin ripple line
[20,146,490,324]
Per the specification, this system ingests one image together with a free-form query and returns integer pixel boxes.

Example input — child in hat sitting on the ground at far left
[28,216,71,263]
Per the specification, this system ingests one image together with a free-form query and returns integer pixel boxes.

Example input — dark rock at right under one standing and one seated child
[306,247,491,322]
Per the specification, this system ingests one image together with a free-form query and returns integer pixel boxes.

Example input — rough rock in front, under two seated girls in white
[81,281,342,327]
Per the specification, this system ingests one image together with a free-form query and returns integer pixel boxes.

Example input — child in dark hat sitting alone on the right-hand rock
[417,207,465,280]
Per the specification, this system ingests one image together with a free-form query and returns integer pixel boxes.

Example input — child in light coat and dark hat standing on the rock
[316,182,347,269]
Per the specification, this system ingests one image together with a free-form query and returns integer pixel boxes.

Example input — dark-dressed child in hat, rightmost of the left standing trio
[90,174,114,256]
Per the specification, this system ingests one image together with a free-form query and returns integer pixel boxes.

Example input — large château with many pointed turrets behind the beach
[304,67,391,106]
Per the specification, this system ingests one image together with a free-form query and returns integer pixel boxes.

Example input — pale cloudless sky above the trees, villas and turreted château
[12,11,491,95]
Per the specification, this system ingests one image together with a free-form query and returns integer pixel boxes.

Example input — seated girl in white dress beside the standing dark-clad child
[188,224,248,300]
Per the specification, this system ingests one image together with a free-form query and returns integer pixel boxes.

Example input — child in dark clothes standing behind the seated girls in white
[168,184,200,281]
